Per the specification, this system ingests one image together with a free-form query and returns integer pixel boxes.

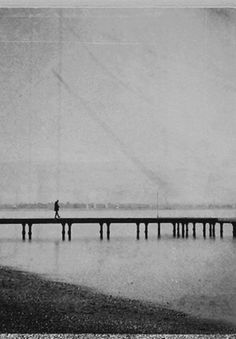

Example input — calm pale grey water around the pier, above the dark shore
[0,210,236,324]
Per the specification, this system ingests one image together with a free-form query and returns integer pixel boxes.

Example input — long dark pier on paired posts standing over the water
[0,217,236,241]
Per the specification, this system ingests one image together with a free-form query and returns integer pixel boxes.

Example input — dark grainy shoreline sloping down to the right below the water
[0,267,236,334]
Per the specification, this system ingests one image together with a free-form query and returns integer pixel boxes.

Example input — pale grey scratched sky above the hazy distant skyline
[0,8,236,204]
